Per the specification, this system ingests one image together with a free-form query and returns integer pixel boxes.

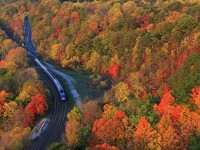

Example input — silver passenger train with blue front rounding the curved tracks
[35,58,66,101]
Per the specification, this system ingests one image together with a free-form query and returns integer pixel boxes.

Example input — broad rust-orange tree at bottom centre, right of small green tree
[89,110,132,149]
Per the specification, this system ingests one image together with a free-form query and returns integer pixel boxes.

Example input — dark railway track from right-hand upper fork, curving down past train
[24,16,67,150]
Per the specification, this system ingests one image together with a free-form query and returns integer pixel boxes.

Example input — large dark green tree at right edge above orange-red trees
[167,54,200,103]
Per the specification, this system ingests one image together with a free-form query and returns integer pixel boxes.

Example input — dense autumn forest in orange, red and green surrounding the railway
[0,0,200,150]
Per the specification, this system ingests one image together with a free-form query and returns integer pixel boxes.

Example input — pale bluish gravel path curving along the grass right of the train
[44,62,81,107]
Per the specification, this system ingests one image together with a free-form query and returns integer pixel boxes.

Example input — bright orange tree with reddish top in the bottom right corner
[157,105,200,149]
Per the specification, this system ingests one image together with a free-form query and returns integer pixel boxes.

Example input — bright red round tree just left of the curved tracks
[26,94,47,116]
